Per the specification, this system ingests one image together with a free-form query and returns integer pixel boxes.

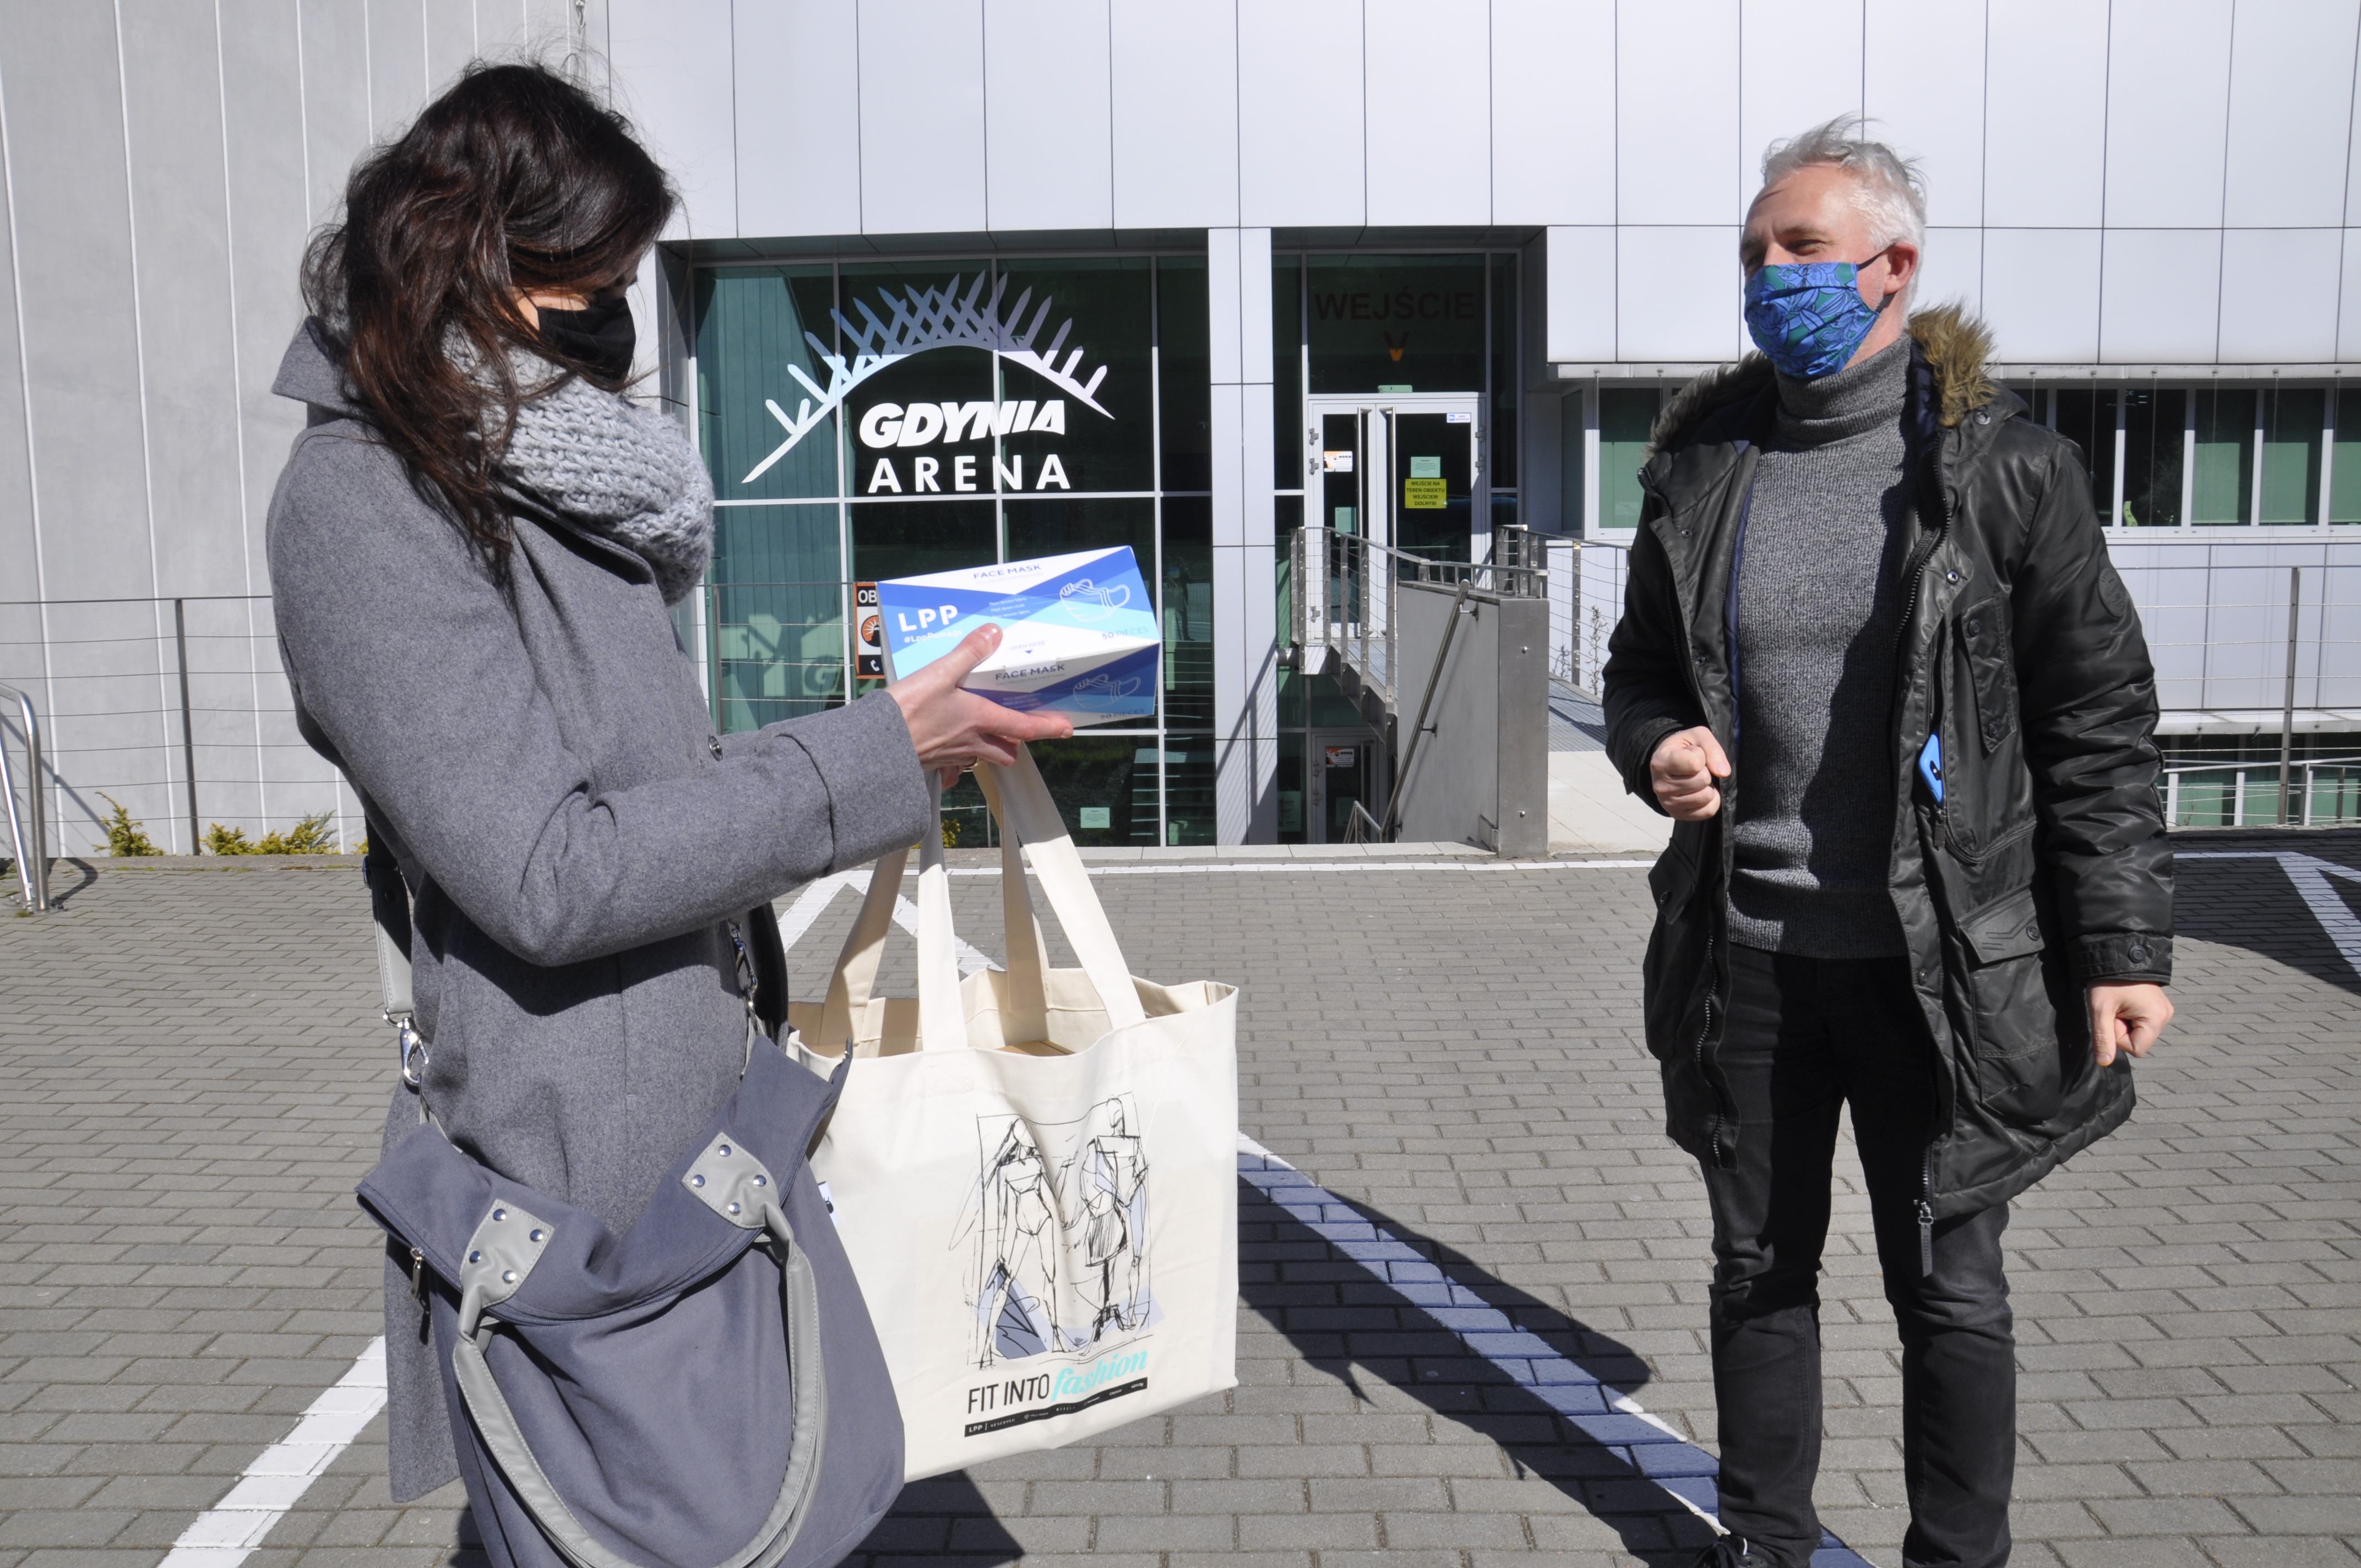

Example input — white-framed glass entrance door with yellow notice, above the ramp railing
[1303,392,1492,560]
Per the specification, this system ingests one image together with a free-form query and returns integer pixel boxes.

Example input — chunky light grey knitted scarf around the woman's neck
[501,354,713,605]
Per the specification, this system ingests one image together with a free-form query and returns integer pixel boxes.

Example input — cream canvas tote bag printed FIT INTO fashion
[788,751,1237,1480]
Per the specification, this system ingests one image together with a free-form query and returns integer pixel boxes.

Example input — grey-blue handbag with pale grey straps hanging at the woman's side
[359,845,902,1568]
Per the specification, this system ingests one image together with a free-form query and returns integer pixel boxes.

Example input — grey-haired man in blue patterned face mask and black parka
[1606,116,2172,1568]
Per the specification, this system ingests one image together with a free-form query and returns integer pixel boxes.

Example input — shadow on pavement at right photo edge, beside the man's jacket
[2172,829,2361,997]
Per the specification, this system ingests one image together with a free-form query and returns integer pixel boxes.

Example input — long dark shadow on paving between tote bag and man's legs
[1237,1181,1714,1568]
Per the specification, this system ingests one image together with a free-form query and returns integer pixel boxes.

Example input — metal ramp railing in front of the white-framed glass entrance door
[1289,524,1549,711]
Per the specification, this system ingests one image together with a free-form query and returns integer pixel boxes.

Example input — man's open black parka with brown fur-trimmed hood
[1606,309,2172,1216]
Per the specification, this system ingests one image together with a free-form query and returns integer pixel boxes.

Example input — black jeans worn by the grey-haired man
[1705,947,2016,1568]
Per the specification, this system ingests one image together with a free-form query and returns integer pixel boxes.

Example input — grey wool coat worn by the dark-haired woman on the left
[269,328,933,1502]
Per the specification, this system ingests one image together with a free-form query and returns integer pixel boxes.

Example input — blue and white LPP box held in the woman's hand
[878,546,1164,729]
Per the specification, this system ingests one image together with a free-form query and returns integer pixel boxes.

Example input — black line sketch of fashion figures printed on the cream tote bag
[951,1093,1155,1367]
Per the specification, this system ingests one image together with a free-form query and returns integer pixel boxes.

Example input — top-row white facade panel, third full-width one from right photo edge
[1983,0,2108,227]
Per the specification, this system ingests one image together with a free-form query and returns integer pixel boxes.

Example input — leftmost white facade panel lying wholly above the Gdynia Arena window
[730,0,862,236]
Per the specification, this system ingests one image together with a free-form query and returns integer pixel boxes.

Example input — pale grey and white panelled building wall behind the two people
[0,0,2361,848]
